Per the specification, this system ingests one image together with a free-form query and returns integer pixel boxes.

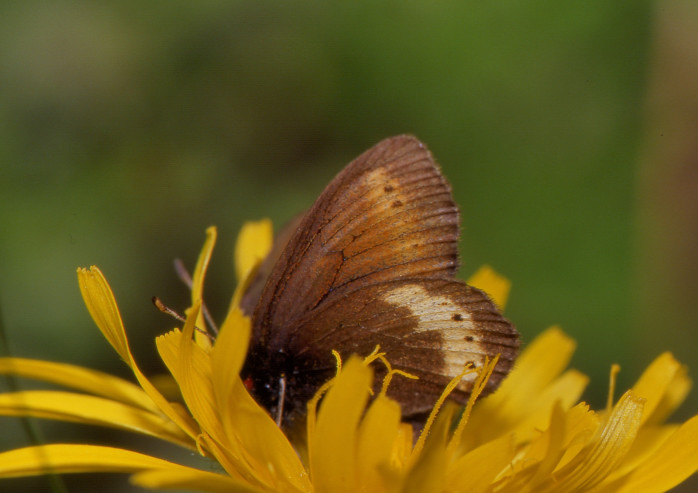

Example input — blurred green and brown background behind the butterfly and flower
[0,0,698,491]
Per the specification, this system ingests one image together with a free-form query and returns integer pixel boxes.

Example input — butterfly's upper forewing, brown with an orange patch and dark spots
[254,136,459,348]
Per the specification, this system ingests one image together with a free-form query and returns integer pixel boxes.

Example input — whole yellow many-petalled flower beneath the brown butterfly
[0,223,698,493]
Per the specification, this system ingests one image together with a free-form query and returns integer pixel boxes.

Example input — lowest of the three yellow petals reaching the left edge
[0,444,188,478]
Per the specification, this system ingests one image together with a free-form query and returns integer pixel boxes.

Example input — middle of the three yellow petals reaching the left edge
[0,390,193,448]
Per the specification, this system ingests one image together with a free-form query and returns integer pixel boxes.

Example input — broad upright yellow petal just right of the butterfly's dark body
[308,357,372,493]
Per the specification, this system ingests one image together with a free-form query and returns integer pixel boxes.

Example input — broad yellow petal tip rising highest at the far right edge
[633,353,691,424]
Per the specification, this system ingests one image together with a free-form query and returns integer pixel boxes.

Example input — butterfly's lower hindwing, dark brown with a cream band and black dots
[286,279,519,416]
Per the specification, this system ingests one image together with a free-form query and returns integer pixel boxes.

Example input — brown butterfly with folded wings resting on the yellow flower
[242,135,519,422]
